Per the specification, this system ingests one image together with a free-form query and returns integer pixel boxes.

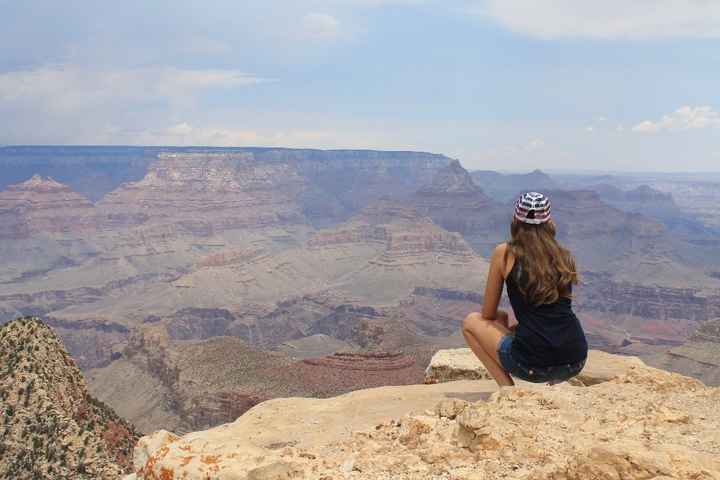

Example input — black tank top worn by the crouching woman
[505,259,588,367]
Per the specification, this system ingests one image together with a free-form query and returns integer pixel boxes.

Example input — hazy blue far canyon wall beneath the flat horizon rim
[0,146,450,215]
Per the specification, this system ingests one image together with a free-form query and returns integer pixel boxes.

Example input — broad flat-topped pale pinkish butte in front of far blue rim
[99,153,303,237]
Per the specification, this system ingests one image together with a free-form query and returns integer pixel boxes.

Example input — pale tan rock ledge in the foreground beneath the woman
[126,348,720,480]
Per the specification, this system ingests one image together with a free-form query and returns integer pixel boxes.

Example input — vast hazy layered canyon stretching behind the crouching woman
[0,147,720,433]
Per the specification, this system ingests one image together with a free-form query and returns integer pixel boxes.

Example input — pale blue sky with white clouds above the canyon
[0,0,720,171]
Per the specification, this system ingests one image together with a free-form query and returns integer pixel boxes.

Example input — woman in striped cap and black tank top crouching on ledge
[463,192,588,386]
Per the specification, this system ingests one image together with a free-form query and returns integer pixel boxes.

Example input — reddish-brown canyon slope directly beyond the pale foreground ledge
[87,324,422,432]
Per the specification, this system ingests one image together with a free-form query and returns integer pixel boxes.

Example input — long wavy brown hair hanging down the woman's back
[506,218,579,305]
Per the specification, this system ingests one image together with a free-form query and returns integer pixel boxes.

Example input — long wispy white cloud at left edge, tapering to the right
[0,66,267,111]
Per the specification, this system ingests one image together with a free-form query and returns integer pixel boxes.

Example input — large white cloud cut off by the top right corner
[473,0,720,39]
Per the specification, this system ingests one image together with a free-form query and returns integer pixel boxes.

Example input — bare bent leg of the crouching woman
[462,312,515,387]
